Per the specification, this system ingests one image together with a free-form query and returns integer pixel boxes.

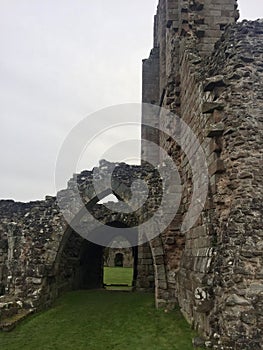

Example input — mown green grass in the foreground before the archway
[0,290,203,350]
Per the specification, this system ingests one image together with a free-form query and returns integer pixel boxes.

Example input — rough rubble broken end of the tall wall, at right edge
[205,21,263,349]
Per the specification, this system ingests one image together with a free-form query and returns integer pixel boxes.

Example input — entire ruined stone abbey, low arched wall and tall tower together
[0,0,263,350]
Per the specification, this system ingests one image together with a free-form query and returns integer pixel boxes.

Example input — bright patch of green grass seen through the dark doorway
[104,267,133,286]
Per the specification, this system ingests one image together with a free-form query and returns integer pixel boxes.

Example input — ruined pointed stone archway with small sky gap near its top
[50,161,159,300]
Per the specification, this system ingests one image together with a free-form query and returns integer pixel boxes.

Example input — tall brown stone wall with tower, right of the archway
[142,0,263,349]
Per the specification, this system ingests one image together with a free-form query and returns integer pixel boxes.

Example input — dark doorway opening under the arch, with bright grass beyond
[56,222,138,293]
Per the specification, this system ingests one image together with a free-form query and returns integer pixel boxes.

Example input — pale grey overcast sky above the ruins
[0,0,263,201]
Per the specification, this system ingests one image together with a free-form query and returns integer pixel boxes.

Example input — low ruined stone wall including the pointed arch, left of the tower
[0,161,160,318]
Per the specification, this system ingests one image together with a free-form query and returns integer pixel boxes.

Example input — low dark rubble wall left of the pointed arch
[0,197,66,307]
